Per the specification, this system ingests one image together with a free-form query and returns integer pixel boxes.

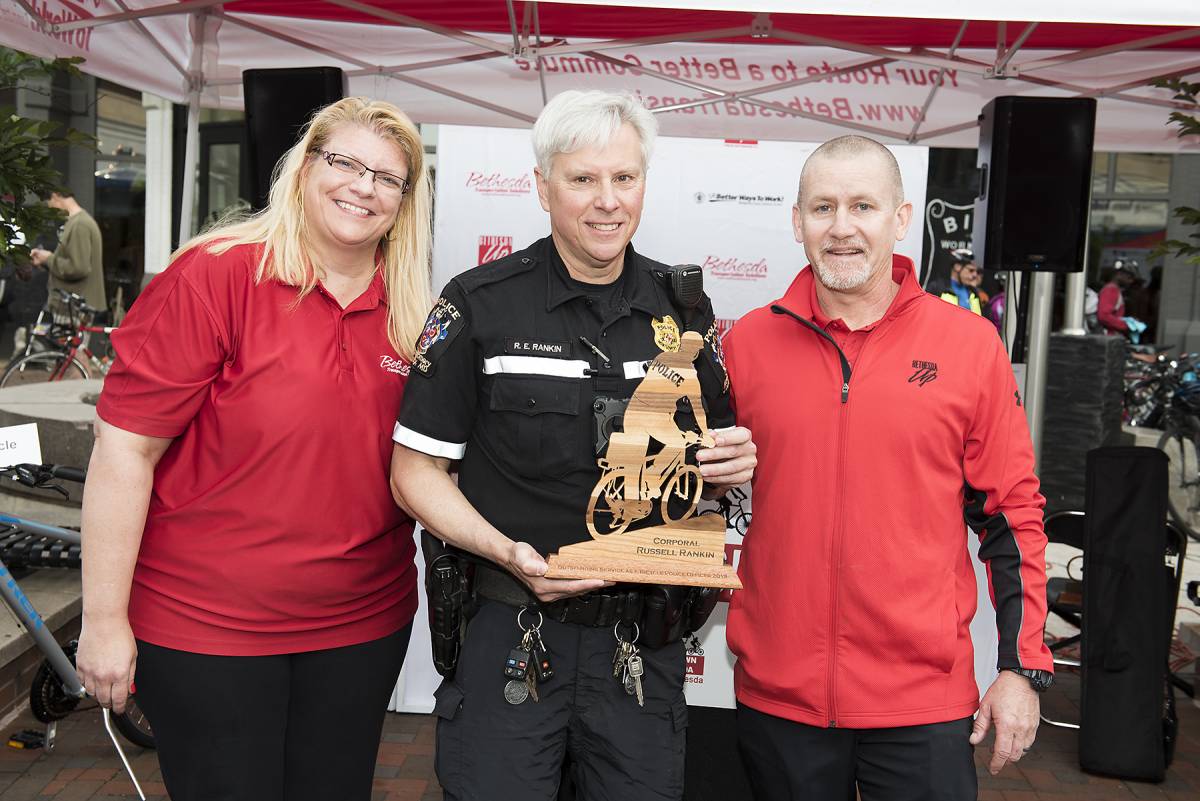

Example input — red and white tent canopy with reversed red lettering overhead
[0,0,1200,151]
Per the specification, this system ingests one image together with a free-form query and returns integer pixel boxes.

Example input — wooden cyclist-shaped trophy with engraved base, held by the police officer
[546,326,742,589]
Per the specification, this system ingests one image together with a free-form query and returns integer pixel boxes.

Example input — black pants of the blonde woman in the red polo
[137,625,413,801]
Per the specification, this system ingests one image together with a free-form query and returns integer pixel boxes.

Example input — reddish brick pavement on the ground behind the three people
[0,674,1200,801]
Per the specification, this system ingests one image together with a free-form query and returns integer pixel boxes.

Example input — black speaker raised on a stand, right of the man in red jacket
[974,97,1096,272]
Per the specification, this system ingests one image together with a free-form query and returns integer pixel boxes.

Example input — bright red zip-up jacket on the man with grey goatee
[725,255,1052,728]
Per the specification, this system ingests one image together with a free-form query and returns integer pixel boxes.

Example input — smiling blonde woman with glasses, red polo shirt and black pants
[78,98,430,801]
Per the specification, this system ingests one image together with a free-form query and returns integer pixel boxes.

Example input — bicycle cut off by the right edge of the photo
[1153,359,1200,540]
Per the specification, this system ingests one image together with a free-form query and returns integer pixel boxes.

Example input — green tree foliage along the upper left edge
[0,47,95,265]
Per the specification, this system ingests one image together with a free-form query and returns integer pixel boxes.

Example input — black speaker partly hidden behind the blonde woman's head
[241,67,346,210]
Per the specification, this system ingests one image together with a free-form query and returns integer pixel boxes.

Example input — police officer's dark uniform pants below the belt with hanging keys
[436,601,688,801]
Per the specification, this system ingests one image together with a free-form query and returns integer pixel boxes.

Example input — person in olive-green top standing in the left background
[29,189,108,323]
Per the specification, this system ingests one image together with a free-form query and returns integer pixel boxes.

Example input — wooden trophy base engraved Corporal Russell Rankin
[546,513,742,590]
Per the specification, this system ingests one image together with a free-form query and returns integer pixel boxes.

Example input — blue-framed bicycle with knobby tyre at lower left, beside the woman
[0,464,155,801]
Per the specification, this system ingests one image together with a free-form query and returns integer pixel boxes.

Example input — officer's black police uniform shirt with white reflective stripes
[392,236,733,554]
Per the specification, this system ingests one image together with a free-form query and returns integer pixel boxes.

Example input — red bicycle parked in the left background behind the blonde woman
[0,289,116,387]
